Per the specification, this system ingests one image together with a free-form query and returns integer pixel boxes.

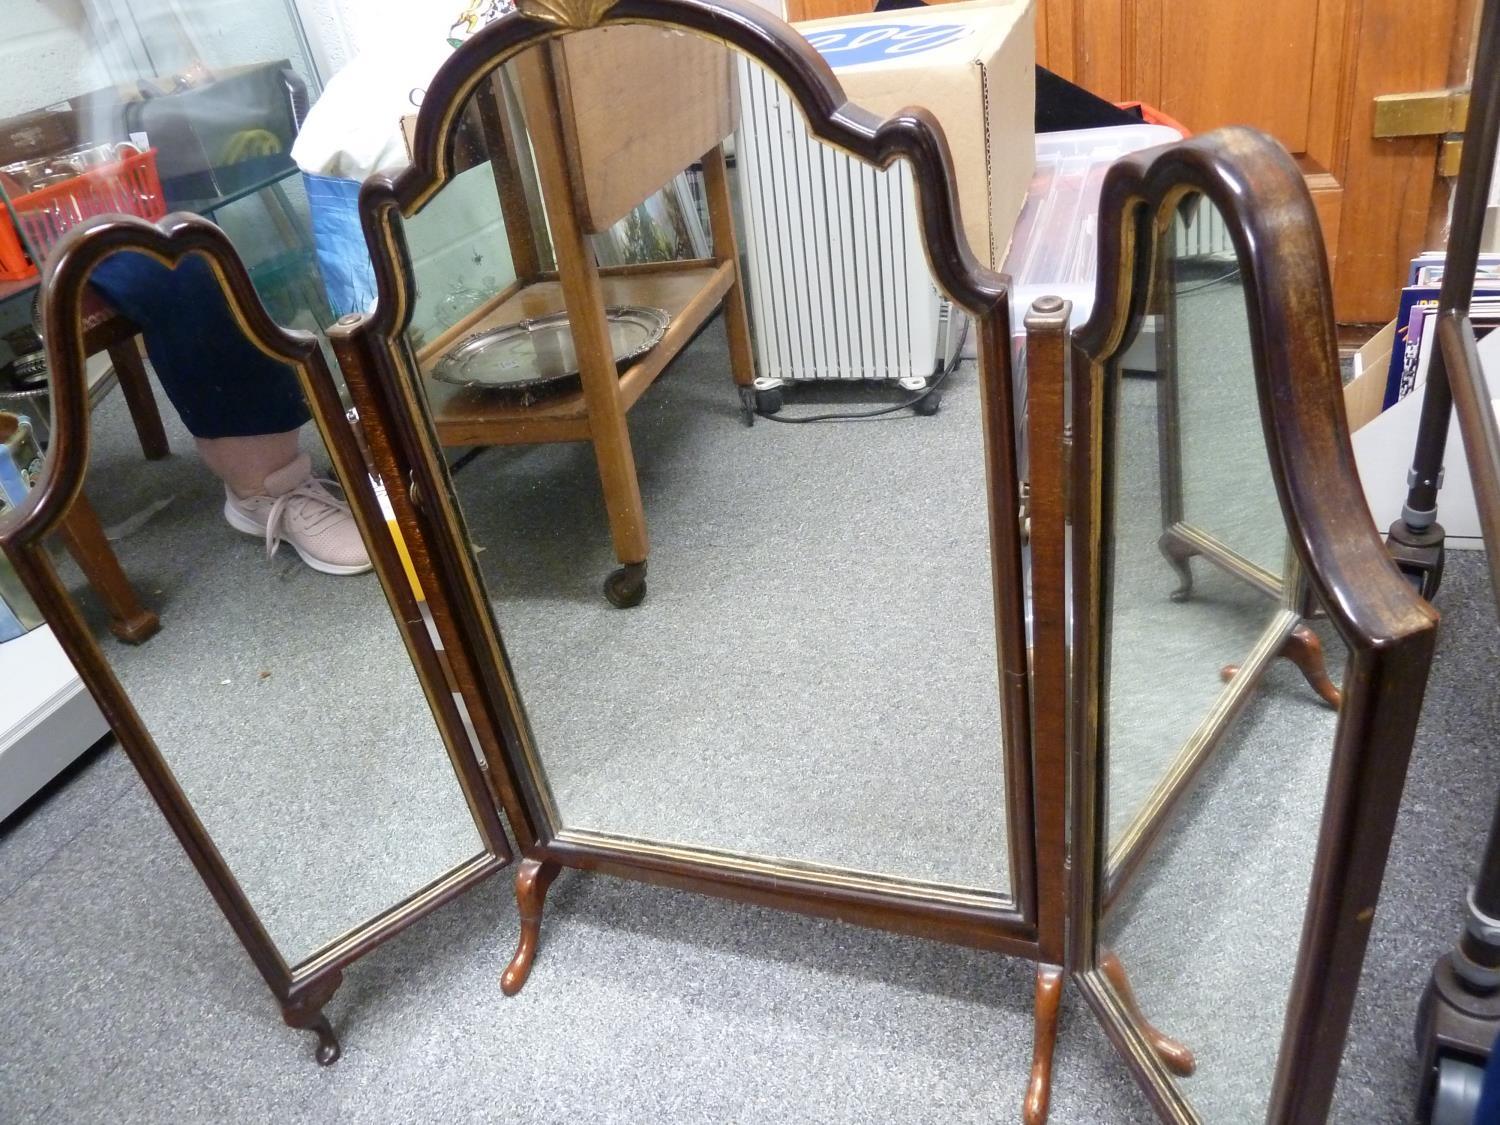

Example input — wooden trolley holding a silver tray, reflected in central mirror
[419,27,753,606]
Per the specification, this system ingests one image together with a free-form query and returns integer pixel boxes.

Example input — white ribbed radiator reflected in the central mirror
[735,59,959,387]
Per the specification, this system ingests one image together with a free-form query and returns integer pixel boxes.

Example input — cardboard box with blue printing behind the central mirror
[795,0,1037,269]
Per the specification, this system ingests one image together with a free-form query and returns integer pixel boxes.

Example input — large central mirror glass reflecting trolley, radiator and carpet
[404,41,1020,902]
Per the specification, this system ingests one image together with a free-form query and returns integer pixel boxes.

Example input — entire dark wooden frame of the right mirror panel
[1050,129,1437,1125]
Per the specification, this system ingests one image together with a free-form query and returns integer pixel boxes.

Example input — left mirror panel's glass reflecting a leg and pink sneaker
[45,252,485,965]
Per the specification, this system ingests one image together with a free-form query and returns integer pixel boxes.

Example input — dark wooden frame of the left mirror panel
[0,215,513,1065]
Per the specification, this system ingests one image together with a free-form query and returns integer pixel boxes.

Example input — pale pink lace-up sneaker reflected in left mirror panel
[224,453,371,575]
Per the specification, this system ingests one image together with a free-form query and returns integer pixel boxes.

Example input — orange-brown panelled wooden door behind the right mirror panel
[1037,0,1470,323]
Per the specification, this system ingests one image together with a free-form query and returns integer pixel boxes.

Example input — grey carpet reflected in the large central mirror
[458,313,1010,891]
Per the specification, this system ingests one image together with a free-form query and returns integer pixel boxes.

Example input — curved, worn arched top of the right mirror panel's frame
[1074,128,1436,645]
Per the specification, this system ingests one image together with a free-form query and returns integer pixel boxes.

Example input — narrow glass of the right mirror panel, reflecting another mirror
[1100,197,1343,1121]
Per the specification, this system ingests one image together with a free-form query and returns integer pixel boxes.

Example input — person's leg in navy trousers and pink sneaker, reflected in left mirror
[93,254,371,575]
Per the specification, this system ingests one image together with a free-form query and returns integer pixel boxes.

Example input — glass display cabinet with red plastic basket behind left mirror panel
[0,0,330,324]
